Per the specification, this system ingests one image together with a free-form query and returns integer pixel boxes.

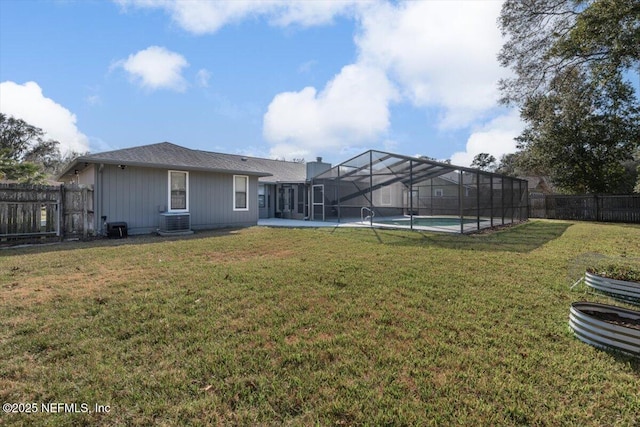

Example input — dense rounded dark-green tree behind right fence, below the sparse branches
[516,69,640,193]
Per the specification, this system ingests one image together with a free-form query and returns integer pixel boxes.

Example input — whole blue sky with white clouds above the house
[0,0,544,165]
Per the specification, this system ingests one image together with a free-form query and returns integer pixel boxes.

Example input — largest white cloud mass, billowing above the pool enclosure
[264,1,502,159]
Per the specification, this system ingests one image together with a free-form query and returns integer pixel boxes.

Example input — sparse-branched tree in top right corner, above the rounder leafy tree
[498,0,640,105]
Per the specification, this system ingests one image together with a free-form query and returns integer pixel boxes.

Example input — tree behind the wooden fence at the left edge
[0,113,62,183]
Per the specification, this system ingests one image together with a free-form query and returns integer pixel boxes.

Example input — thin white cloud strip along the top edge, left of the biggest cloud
[114,0,366,34]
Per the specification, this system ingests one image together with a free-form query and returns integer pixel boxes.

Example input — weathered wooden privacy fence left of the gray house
[0,184,94,244]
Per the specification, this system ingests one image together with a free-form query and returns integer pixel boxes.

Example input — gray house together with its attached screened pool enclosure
[59,142,528,234]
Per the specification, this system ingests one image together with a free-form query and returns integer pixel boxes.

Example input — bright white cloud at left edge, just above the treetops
[0,81,89,153]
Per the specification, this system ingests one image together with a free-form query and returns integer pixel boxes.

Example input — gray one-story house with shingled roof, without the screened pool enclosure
[59,142,331,234]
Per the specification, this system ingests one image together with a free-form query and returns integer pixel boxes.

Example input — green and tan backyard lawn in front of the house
[0,221,640,426]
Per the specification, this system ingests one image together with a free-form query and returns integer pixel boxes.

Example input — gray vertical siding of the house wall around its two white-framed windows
[97,165,258,234]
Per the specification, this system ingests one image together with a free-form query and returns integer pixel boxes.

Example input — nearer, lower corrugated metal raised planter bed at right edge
[569,302,640,357]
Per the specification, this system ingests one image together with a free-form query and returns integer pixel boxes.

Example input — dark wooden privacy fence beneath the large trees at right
[529,193,640,224]
